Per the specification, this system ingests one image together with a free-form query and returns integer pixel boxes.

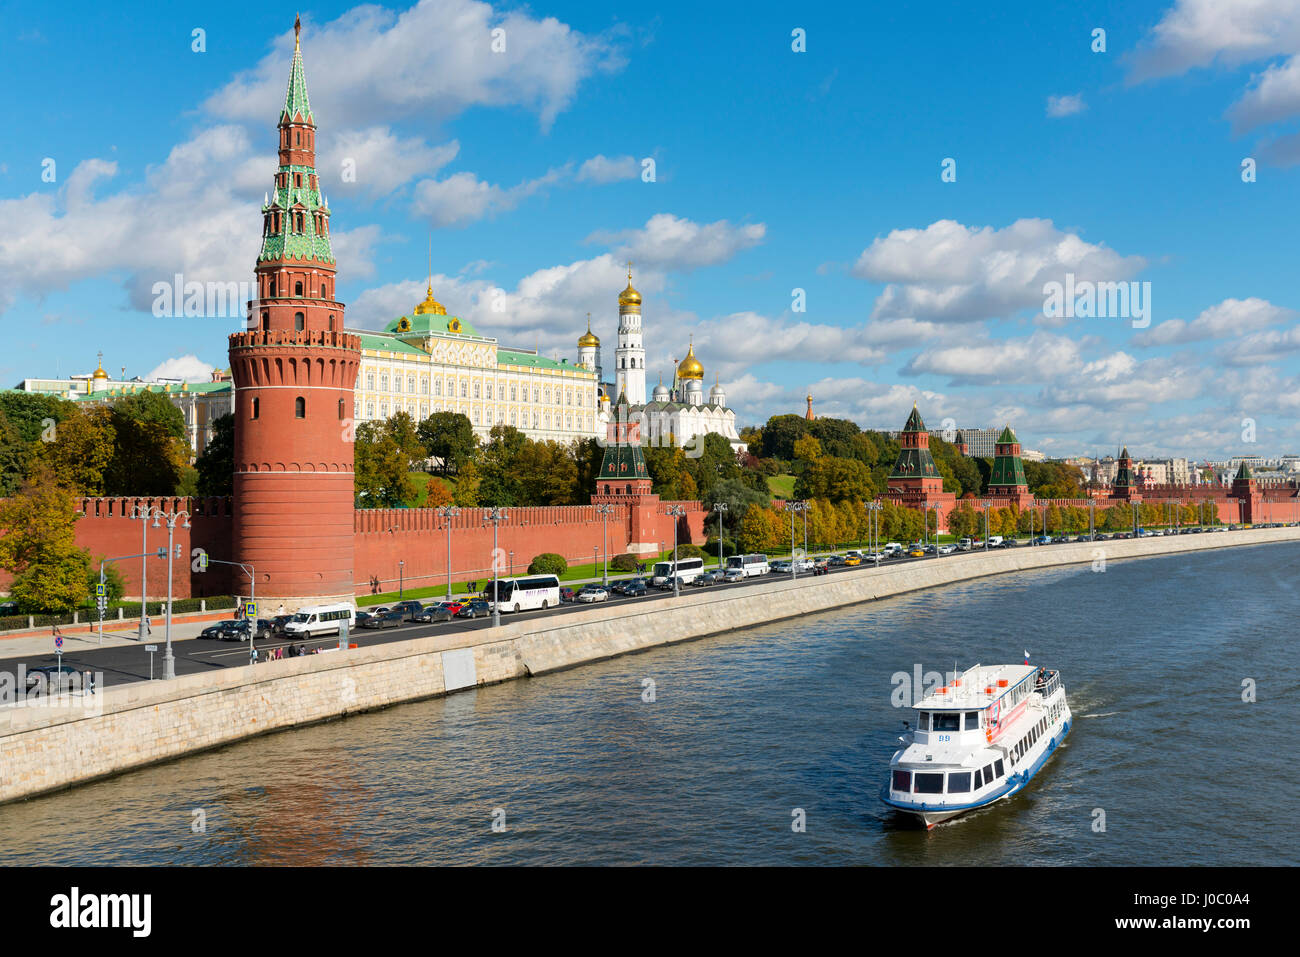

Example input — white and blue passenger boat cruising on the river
[880,661,1071,828]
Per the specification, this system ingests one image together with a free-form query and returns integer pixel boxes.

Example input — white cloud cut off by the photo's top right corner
[1130,0,1300,82]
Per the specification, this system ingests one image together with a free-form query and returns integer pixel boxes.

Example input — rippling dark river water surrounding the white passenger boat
[0,545,1300,865]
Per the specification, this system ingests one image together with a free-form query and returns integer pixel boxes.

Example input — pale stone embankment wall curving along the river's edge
[0,528,1300,801]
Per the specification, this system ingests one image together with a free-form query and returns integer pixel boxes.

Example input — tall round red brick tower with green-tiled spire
[230,22,361,611]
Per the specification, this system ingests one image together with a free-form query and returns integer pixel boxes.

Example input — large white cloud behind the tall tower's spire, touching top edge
[204,0,623,129]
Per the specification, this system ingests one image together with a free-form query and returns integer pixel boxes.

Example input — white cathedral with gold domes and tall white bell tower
[577,265,746,454]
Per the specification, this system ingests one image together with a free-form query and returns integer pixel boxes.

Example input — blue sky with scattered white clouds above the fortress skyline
[0,0,1300,458]
